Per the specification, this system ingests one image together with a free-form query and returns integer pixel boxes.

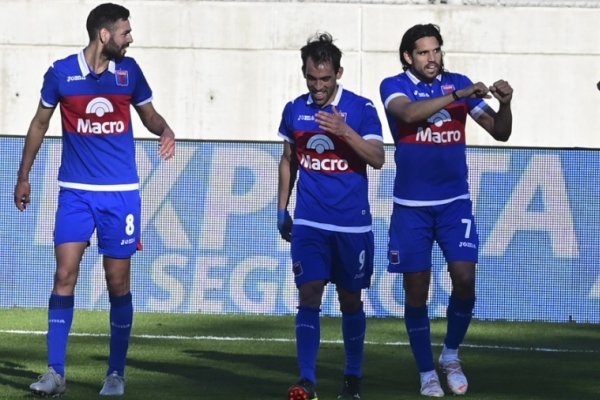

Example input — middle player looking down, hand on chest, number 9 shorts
[277,33,384,400]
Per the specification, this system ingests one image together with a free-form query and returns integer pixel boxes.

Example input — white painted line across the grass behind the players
[0,329,600,354]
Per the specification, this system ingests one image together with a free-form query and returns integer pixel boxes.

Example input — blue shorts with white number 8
[54,188,141,258]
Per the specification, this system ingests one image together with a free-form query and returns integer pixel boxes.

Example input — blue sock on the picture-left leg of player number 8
[46,293,75,377]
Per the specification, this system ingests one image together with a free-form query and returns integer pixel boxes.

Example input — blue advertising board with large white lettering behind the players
[0,137,600,323]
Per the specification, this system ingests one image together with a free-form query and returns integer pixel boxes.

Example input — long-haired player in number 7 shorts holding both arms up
[380,24,513,397]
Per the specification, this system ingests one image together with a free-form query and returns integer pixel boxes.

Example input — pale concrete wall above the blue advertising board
[0,0,600,147]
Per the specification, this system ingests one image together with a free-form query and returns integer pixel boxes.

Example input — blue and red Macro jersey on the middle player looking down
[279,85,383,233]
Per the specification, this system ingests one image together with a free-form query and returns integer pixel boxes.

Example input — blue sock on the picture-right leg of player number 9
[342,307,367,378]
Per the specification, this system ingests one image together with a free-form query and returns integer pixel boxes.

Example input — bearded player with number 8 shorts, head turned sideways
[14,4,175,396]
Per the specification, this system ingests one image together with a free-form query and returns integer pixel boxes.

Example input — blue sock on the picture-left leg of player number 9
[296,306,321,384]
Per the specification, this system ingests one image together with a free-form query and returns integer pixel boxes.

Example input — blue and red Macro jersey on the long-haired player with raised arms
[379,71,488,206]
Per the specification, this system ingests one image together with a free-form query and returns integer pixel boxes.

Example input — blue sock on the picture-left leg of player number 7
[404,304,435,372]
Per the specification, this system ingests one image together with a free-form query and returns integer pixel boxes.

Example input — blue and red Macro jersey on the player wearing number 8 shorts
[41,51,152,190]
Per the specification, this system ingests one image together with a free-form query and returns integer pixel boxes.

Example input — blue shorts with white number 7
[388,200,479,272]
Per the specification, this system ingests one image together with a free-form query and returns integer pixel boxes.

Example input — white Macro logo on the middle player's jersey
[300,134,348,172]
